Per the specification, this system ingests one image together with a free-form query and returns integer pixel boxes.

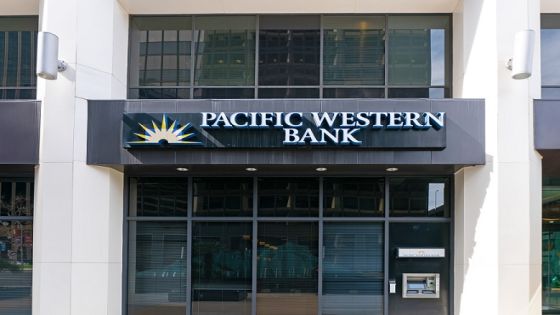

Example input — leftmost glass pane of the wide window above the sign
[129,16,192,92]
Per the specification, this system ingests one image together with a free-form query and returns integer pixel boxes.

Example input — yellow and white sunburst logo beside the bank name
[128,114,201,146]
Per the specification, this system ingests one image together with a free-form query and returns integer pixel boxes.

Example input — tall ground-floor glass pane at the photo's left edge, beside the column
[0,220,33,315]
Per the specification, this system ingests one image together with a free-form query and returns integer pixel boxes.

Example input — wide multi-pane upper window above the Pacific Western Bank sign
[129,15,451,99]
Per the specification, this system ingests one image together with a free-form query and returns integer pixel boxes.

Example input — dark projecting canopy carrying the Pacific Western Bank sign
[87,99,485,174]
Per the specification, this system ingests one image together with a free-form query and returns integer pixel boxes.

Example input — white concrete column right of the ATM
[453,0,541,315]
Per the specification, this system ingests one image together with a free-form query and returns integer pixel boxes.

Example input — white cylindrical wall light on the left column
[37,32,67,80]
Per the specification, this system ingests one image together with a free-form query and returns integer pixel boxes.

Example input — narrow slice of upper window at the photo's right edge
[541,14,560,99]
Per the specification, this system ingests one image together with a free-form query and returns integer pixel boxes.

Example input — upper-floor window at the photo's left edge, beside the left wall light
[0,17,38,99]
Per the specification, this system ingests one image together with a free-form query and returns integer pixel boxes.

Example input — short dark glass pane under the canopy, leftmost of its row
[129,178,187,217]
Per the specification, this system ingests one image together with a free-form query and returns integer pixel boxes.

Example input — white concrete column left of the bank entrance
[33,0,128,315]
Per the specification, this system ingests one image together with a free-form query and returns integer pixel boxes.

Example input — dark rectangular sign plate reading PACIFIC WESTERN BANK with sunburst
[123,112,446,150]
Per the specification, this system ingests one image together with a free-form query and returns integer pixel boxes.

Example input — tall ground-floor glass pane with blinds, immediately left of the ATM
[321,223,384,315]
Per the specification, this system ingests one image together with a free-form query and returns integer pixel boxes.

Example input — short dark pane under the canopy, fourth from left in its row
[323,178,385,217]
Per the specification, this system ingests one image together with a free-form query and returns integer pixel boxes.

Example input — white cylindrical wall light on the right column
[506,30,535,80]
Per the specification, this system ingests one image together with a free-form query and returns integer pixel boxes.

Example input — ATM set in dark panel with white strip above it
[388,223,450,315]
